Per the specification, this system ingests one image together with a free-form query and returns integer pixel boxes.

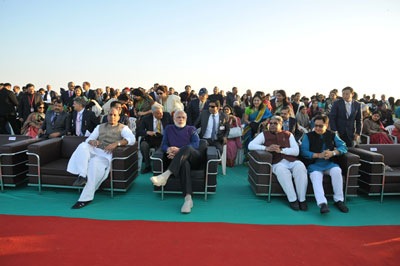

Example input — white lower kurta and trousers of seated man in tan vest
[67,142,112,201]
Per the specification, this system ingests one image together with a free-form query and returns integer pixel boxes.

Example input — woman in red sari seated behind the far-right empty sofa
[362,111,393,144]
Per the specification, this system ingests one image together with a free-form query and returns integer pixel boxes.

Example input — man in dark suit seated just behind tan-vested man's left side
[71,97,99,136]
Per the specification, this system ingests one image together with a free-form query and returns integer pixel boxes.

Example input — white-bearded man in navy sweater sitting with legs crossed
[150,110,204,213]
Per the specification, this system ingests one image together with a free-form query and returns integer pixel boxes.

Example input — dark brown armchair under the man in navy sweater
[151,139,221,200]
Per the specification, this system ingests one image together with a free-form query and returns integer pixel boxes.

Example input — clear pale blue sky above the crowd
[0,0,400,98]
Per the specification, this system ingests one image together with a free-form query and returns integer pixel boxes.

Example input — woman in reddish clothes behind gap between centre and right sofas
[223,105,242,167]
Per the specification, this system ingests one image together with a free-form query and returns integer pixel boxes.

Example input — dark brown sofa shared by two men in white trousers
[248,151,360,202]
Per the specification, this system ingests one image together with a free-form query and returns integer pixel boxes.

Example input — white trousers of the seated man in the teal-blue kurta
[310,166,344,206]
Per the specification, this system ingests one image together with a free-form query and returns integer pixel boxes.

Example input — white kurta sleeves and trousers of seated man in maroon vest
[249,133,308,202]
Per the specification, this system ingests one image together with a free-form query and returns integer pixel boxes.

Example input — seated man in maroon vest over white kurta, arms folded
[249,116,308,211]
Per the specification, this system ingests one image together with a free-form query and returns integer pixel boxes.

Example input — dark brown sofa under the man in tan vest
[27,136,138,196]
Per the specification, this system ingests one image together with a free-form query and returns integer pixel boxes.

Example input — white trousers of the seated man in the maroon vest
[272,159,308,202]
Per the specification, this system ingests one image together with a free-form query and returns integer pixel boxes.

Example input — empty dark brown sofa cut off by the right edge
[349,144,400,202]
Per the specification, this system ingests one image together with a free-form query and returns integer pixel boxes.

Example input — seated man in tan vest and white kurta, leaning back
[67,108,135,209]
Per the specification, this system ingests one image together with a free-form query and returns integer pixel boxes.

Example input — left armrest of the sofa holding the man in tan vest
[28,138,62,165]
